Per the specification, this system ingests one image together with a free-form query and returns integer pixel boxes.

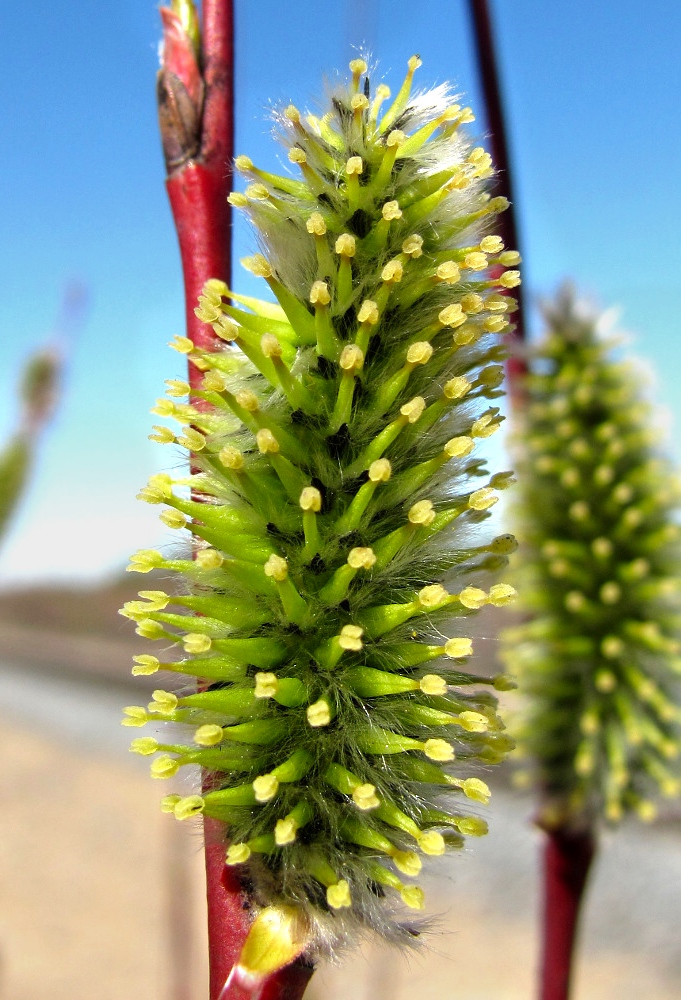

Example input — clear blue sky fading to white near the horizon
[0,0,681,586]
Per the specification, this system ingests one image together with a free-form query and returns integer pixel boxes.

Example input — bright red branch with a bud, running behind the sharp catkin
[159,0,313,1000]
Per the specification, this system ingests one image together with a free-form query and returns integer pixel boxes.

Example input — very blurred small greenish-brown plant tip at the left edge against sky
[0,348,59,536]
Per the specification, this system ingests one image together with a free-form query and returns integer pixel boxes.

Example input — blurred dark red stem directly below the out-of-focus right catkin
[540,830,596,1000]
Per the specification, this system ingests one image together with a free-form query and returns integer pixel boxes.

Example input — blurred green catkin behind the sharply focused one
[505,289,681,827]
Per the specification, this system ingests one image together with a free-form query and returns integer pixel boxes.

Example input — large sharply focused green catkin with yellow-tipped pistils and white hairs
[123,57,518,964]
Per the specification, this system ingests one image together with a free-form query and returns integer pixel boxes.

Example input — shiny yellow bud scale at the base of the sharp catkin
[235,904,311,983]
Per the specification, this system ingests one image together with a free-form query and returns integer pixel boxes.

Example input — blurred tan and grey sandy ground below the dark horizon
[0,660,681,1000]
